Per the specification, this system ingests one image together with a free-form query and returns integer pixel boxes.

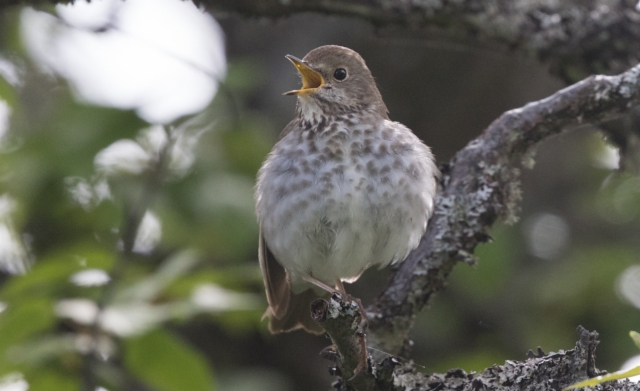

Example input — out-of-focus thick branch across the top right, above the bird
[206,0,640,82]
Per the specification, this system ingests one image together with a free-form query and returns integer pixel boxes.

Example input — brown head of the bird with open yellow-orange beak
[285,45,387,118]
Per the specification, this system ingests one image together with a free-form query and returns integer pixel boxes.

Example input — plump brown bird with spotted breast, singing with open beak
[255,45,439,334]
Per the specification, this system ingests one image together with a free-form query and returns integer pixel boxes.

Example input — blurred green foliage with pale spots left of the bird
[0,4,270,391]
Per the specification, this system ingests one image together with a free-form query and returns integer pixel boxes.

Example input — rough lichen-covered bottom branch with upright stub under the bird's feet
[311,295,637,391]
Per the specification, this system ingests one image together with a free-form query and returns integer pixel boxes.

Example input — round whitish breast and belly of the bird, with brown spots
[258,118,435,290]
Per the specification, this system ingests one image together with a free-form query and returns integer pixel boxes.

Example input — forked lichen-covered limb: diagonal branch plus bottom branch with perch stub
[302,60,640,390]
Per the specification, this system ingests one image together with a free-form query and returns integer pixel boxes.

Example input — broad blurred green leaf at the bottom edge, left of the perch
[124,329,215,391]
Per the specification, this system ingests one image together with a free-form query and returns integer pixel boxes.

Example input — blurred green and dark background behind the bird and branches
[0,0,640,391]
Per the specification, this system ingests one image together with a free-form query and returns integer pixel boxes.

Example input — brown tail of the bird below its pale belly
[263,289,328,334]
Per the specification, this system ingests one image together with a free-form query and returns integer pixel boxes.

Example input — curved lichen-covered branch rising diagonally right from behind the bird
[368,62,640,354]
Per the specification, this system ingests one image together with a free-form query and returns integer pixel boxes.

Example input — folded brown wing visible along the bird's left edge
[258,227,291,319]
